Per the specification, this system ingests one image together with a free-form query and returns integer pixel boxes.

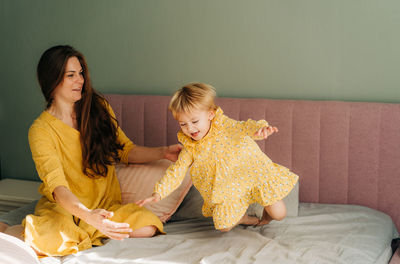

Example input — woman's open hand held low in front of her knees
[83,209,132,240]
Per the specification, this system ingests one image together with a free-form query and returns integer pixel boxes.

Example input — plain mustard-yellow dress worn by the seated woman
[22,106,163,256]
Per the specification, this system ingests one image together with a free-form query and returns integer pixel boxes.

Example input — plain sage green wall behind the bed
[0,0,400,179]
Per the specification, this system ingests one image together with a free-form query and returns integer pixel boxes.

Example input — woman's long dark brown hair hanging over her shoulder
[37,45,123,178]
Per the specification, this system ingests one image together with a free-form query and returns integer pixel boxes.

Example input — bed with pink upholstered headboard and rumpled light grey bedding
[0,94,400,264]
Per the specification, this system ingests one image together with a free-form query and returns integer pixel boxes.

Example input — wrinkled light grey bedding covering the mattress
[41,203,398,264]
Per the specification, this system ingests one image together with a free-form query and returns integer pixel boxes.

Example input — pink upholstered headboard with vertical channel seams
[106,94,400,229]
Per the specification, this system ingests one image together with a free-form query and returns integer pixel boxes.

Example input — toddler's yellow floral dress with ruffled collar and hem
[154,108,298,229]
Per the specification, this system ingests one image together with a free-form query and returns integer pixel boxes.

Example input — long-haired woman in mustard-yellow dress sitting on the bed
[18,46,181,256]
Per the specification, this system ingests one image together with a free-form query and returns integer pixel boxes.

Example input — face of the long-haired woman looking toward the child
[53,57,85,103]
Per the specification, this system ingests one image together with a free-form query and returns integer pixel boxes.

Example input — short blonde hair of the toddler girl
[168,83,217,118]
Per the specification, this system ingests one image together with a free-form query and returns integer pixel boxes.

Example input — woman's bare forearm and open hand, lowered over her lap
[53,186,132,240]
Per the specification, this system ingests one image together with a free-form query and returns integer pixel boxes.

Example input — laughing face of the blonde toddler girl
[177,109,215,141]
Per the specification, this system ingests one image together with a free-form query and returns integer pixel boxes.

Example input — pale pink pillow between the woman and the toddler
[116,159,192,223]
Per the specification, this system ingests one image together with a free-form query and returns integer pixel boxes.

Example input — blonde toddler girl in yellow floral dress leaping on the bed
[137,83,298,231]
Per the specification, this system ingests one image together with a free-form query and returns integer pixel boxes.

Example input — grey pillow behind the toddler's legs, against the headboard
[171,182,299,221]
